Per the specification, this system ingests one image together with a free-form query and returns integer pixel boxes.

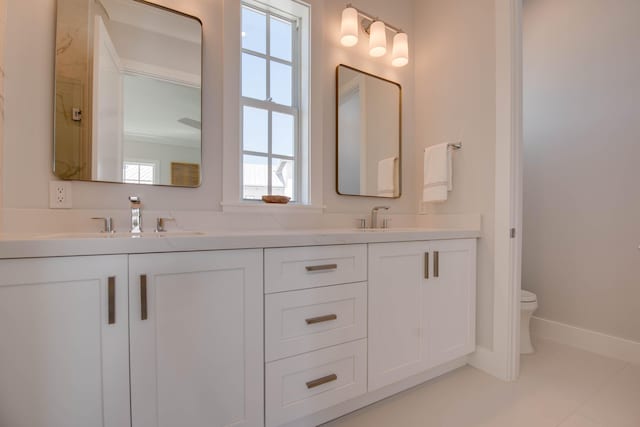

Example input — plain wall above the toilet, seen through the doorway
[523,0,640,342]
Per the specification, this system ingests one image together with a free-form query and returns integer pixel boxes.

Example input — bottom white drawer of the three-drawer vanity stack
[265,339,367,427]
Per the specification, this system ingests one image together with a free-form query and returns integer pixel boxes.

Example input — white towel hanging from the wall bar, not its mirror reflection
[422,142,453,202]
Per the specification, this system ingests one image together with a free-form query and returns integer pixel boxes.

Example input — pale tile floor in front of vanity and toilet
[325,341,640,427]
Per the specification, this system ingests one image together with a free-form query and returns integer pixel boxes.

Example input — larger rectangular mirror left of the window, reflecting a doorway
[53,0,202,187]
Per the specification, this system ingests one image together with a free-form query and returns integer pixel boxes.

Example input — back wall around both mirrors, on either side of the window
[2,0,417,221]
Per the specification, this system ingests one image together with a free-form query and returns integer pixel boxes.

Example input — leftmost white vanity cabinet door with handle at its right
[0,256,130,427]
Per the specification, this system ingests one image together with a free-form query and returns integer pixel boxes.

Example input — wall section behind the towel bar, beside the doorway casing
[413,0,496,349]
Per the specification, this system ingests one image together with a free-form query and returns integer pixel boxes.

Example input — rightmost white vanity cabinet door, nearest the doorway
[425,239,476,366]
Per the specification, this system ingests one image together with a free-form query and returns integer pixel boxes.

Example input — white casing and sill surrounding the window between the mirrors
[221,0,324,213]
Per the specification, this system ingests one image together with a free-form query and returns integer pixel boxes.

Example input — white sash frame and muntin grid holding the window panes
[239,0,305,203]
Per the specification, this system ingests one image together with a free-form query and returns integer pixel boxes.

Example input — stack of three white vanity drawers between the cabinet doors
[264,244,367,427]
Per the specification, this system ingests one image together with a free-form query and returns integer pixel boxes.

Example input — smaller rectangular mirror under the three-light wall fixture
[336,65,402,198]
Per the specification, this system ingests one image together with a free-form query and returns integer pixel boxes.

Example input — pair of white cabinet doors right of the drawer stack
[368,239,476,391]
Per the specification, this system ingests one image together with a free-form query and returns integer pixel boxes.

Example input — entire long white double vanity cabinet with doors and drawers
[0,231,476,427]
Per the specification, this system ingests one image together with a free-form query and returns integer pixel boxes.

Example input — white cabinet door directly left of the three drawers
[129,250,264,427]
